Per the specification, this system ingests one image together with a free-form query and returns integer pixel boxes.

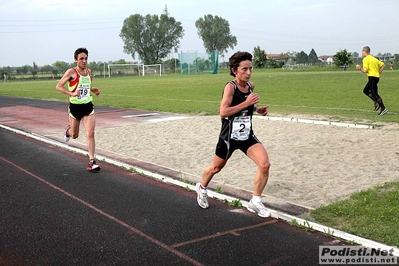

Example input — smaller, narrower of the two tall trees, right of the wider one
[195,15,237,56]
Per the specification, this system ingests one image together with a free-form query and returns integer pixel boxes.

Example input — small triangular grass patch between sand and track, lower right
[311,182,399,246]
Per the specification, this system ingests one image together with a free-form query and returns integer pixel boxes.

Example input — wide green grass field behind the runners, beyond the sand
[0,69,399,123]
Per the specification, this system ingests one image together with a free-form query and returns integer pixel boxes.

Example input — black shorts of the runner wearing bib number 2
[215,134,261,160]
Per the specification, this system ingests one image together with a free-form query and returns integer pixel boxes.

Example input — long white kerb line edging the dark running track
[0,124,399,257]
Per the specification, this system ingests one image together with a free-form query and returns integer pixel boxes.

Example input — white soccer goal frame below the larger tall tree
[108,64,162,78]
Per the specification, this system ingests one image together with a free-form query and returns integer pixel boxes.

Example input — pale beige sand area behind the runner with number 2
[72,116,399,208]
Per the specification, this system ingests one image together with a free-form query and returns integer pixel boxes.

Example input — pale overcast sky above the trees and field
[0,0,399,67]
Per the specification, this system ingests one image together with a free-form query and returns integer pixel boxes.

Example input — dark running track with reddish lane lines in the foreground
[0,96,345,265]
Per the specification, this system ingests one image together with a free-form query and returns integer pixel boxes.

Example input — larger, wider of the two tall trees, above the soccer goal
[119,14,184,65]
